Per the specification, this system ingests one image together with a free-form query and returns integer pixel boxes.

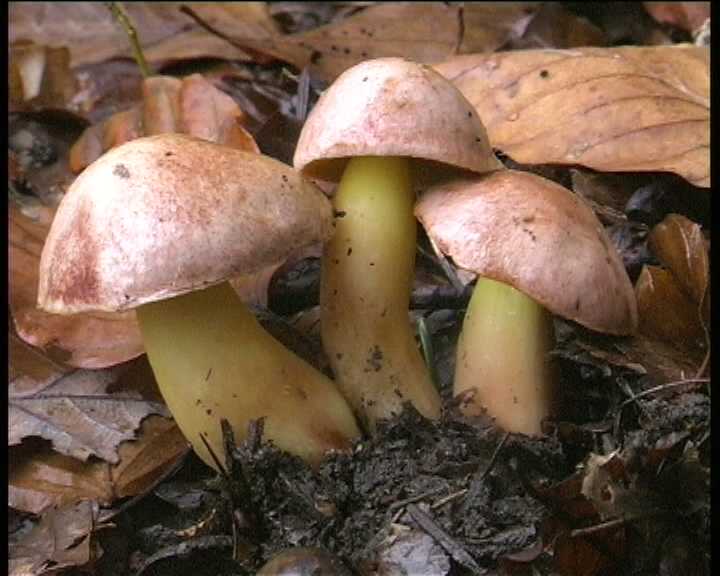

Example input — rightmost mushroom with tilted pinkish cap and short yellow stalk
[415,170,638,435]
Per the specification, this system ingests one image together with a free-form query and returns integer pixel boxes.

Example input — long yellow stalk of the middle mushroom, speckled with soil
[320,157,440,431]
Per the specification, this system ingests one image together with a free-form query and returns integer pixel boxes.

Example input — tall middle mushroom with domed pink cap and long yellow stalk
[293,58,501,431]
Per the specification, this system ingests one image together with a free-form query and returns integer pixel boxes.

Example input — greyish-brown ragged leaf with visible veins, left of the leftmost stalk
[8,362,169,463]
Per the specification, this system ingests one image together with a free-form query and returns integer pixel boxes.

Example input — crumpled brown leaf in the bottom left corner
[8,501,101,576]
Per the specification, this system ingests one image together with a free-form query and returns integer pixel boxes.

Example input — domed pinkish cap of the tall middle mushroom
[293,58,502,181]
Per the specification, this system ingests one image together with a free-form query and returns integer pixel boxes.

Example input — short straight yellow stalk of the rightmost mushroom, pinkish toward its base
[454,278,554,435]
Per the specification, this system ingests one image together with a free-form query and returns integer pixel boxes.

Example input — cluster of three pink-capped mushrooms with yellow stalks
[38,58,637,466]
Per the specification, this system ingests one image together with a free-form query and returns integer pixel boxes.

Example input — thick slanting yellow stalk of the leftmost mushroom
[137,283,359,467]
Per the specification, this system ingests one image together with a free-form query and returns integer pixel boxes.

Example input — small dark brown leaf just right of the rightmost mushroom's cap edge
[635,266,704,349]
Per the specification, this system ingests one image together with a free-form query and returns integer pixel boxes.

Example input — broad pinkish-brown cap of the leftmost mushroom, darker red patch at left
[38,134,333,314]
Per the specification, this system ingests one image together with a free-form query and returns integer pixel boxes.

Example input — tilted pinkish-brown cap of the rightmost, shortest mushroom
[415,170,638,334]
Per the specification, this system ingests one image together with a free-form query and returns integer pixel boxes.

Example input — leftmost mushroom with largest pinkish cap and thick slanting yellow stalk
[38,134,359,465]
